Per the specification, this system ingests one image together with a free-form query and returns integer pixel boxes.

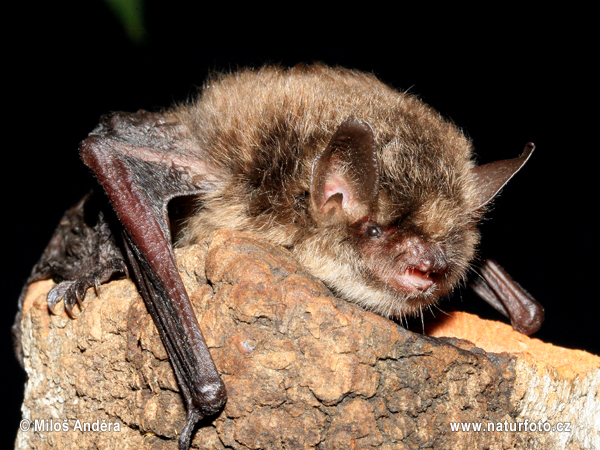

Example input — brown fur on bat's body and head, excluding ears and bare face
[172,65,480,316]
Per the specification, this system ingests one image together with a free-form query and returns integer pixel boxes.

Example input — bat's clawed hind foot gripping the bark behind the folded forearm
[47,258,129,318]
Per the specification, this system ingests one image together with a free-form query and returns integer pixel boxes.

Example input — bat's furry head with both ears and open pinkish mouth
[295,116,532,317]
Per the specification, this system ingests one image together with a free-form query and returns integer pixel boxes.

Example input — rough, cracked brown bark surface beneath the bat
[16,232,600,450]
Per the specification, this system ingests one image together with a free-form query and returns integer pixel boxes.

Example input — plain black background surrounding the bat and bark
[0,0,600,445]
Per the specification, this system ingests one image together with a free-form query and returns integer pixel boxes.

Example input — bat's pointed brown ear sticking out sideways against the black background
[473,142,535,208]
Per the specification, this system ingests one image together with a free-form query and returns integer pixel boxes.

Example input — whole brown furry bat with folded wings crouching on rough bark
[13,64,543,449]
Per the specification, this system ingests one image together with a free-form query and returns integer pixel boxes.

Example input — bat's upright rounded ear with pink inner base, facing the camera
[310,116,379,224]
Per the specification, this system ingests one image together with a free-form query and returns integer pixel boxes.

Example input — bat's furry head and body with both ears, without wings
[182,66,532,316]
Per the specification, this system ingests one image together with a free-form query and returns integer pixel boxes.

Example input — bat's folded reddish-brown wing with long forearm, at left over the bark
[80,111,226,449]
